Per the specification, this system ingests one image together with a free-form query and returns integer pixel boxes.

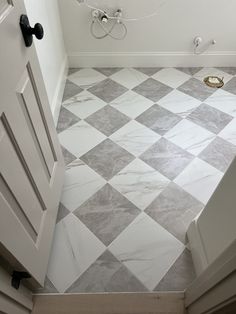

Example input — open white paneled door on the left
[0,0,64,285]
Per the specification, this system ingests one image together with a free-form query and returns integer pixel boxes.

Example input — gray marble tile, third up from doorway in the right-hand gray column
[136,105,181,135]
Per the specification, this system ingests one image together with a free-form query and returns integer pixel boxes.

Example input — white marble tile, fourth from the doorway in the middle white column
[110,91,154,119]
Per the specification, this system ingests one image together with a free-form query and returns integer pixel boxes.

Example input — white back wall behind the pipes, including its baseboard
[59,0,236,66]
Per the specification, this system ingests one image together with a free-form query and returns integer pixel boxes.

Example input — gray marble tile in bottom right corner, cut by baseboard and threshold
[154,249,196,291]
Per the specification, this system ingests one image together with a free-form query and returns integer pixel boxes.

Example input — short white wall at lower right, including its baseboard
[188,158,236,274]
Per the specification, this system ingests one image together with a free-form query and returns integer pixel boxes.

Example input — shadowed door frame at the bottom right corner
[185,240,236,314]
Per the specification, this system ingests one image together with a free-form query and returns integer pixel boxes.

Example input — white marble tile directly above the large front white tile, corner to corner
[109,159,170,210]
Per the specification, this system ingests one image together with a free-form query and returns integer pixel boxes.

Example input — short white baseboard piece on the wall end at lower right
[187,217,209,276]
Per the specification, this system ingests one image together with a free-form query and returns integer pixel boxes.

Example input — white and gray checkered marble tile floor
[37,68,236,293]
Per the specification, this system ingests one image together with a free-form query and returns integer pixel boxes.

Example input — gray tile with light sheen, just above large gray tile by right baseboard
[140,138,194,180]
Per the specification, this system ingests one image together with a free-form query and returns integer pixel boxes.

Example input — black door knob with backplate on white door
[20,14,44,47]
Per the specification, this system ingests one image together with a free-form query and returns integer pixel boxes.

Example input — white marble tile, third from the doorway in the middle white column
[110,120,161,156]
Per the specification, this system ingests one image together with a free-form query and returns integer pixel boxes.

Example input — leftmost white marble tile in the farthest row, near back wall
[68,68,107,88]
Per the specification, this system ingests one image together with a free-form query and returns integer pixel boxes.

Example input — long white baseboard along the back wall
[68,51,236,67]
